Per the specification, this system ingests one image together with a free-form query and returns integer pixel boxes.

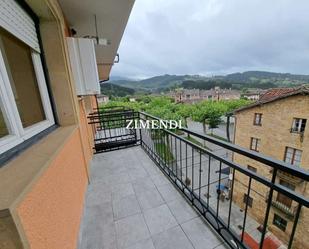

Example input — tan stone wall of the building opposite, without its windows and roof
[233,95,309,248]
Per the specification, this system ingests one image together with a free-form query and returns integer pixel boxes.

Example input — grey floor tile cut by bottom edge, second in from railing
[152,226,193,249]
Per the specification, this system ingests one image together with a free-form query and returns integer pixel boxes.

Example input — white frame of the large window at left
[0,30,55,154]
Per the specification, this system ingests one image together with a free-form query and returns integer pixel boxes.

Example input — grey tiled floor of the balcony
[79,147,227,249]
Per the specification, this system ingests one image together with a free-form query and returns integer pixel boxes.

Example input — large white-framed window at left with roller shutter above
[0,4,54,154]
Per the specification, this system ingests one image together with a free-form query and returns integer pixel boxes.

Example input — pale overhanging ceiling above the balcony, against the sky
[59,0,135,80]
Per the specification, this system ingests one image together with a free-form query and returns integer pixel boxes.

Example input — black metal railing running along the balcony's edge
[90,109,309,249]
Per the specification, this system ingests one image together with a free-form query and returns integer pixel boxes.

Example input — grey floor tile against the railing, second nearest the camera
[167,199,199,224]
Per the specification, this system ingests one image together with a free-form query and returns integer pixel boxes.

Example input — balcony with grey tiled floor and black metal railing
[79,108,309,249]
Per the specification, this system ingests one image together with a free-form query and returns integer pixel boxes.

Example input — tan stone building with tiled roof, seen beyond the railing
[233,87,309,248]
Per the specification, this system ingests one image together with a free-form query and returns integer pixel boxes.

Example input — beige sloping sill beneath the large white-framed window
[0,125,77,211]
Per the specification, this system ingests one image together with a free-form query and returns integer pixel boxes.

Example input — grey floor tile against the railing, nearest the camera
[181,217,223,249]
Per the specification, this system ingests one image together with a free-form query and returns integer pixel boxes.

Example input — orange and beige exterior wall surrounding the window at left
[0,0,97,249]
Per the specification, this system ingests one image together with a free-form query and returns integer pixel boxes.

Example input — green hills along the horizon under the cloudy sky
[103,71,309,95]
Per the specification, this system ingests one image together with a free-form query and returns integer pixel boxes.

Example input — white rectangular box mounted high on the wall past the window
[67,37,100,95]
